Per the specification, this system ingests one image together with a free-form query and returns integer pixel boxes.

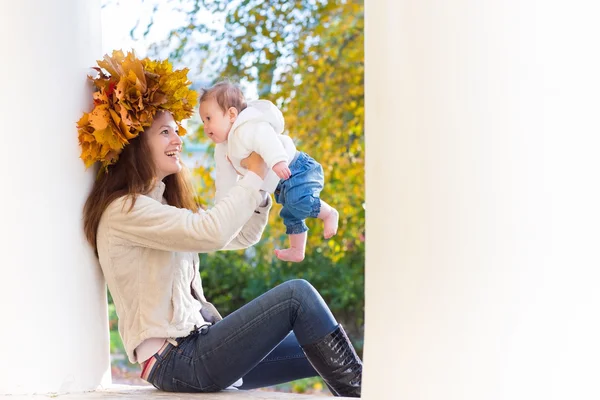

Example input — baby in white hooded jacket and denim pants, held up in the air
[200,82,339,262]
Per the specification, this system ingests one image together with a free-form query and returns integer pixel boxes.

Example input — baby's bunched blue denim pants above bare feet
[275,152,324,235]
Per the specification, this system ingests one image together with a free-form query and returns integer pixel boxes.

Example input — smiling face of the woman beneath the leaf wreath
[145,112,182,181]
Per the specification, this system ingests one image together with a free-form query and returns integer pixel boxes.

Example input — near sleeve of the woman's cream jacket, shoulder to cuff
[103,173,263,253]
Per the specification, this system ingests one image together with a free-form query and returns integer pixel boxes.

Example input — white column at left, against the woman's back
[0,0,110,394]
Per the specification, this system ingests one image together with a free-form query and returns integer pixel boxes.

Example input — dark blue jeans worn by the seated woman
[148,279,337,392]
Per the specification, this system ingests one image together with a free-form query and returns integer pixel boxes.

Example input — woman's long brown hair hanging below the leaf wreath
[83,128,198,254]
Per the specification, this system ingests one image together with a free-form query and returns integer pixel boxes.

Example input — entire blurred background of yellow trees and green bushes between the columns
[139,0,365,339]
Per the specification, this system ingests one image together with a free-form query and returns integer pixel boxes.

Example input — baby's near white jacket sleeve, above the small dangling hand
[239,122,288,168]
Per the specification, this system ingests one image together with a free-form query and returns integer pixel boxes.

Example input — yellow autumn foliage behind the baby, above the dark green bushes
[147,0,365,264]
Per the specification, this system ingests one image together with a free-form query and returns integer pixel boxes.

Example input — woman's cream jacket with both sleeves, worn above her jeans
[96,173,272,363]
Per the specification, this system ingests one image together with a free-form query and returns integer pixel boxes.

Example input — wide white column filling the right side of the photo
[363,0,600,400]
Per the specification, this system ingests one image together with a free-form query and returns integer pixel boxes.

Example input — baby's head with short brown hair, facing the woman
[200,81,247,143]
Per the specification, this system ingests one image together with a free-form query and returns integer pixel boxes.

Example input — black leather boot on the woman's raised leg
[302,325,362,397]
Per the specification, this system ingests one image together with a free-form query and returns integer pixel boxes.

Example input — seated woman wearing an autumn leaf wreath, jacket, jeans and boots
[78,51,362,397]
